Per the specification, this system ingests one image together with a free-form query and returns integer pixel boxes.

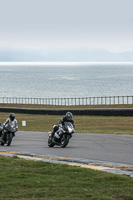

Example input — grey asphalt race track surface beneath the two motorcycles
[0,131,133,165]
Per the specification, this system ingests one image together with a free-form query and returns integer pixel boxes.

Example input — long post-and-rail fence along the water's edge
[0,96,133,106]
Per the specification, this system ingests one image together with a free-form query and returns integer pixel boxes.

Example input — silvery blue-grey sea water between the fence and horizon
[0,64,133,98]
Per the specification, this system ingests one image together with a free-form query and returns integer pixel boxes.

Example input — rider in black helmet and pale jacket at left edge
[1,113,18,143]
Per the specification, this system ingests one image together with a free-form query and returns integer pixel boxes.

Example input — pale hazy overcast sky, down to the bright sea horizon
[0,0,133,62]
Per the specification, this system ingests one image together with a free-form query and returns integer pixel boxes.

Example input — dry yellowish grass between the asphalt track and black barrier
[0,112,133,134]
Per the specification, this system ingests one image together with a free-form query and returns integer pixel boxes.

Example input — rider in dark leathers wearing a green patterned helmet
[52,112,75,136]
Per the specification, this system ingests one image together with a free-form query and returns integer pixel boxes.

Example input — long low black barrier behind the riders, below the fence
[0,107,133,116]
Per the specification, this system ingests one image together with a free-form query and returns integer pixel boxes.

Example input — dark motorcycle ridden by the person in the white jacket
[0,123,17,146]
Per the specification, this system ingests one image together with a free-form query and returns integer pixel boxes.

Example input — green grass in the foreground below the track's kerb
[0,156,133,200]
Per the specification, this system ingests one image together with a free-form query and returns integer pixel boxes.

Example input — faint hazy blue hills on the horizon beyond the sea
[0,48,133,62]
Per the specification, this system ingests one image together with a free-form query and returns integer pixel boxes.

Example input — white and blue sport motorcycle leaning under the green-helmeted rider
[48,122,75,148]
